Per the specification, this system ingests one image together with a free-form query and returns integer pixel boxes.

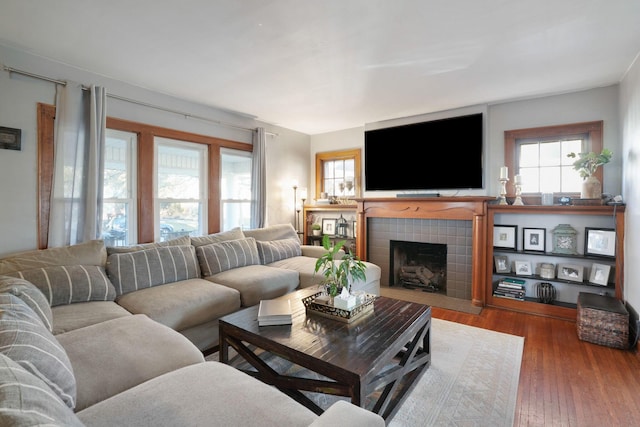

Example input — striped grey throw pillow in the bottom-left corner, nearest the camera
[0,354,83,427]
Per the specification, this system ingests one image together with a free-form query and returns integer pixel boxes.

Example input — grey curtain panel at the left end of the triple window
[48,82,107,247]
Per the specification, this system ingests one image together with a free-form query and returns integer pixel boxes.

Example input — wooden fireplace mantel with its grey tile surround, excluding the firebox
[356,196,494,306]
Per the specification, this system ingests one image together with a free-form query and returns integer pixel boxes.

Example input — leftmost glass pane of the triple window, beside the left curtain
[102,129,138,246]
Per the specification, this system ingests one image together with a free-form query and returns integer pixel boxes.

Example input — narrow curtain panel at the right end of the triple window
[251,127,267,228]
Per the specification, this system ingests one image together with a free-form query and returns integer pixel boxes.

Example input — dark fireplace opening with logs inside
[389,240,447,295]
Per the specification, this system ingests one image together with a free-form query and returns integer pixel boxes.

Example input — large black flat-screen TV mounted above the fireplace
[364,113,484,191]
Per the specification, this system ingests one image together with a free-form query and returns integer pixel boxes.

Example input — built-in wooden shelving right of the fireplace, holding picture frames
[485,204,624,320]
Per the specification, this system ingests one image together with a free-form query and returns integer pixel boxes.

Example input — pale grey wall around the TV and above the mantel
[310,85,622,202]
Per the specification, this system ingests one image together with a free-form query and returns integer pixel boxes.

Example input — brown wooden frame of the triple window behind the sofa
[37,103,253,249]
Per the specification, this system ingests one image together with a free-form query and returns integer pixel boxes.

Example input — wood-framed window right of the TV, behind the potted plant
[505,121,603,201]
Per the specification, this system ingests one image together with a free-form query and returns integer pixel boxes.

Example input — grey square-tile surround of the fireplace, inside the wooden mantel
[367,218,472,300]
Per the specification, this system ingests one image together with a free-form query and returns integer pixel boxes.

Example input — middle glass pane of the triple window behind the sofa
[154,137,207,241]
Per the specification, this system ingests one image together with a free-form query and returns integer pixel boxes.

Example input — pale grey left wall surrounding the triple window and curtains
[0,45,310,256]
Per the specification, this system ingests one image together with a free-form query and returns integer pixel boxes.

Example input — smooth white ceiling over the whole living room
[0,0,640,135]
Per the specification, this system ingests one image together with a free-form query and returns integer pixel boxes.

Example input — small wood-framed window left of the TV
[316,149,361,199]
